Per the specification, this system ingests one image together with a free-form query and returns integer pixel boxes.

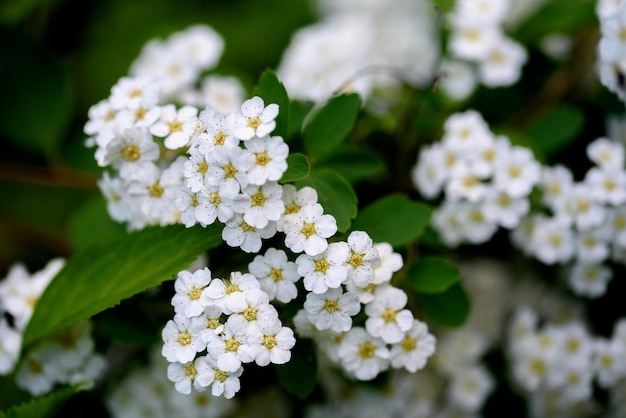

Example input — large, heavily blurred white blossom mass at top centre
[277,0,439,102]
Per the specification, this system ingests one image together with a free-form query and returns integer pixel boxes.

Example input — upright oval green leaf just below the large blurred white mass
[303,93,361,160]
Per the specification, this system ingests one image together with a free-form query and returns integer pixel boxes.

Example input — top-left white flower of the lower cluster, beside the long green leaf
[172,267,211,318]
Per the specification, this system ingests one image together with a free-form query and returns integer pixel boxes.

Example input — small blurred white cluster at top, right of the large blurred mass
[440,0,528,100]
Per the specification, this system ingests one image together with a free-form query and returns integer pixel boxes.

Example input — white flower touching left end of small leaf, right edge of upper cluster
[241,136,289,185]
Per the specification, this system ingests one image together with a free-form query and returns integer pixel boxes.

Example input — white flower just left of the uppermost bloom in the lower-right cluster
[296,242,350,294]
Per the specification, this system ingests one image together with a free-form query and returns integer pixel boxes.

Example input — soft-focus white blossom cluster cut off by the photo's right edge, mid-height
[512,137,626,298]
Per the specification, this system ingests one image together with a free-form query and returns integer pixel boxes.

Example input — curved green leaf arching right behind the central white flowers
[296,168,357,232]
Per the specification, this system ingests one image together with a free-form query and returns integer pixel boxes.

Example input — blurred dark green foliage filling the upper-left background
[0,0,314,273]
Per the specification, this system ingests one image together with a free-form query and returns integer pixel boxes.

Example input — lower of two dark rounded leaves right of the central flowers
[416,282,471,328]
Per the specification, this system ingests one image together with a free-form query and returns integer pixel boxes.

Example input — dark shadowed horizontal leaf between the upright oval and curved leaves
[320,150,386,183]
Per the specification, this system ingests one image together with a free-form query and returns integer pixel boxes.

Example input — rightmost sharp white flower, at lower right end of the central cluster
[389,319,436,373]
